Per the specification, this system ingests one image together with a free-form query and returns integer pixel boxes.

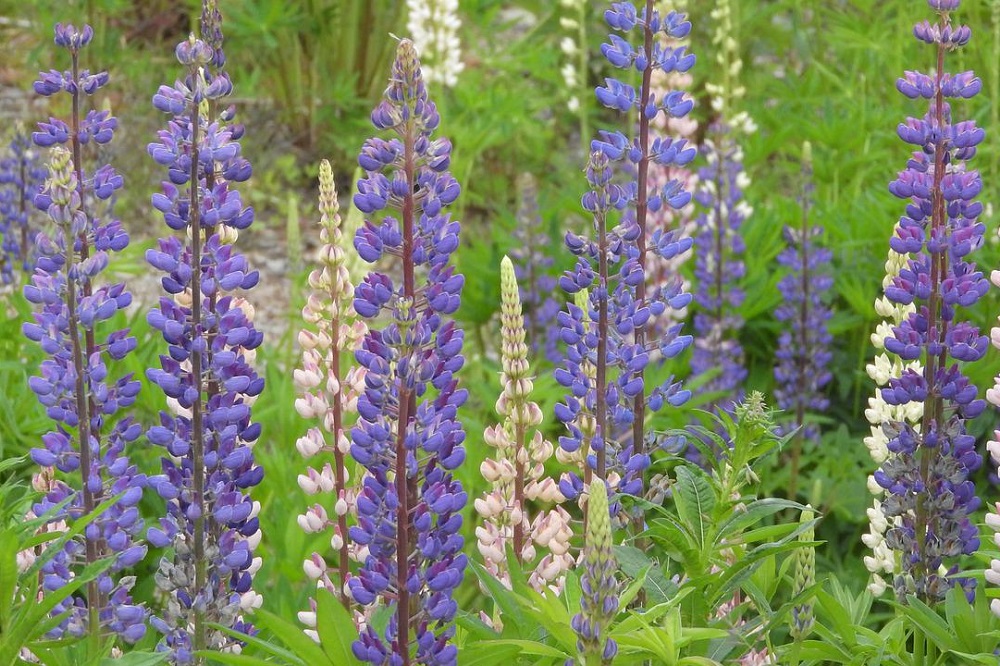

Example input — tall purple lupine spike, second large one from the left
[146,10,264,663]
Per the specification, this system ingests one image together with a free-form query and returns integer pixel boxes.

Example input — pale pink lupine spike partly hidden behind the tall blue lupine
[646,0,699,334]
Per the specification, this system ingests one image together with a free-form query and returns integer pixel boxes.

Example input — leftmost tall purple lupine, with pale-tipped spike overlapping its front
[24,24,146,642]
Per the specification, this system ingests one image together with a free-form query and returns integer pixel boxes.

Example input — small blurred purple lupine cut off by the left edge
[0,123,46,284]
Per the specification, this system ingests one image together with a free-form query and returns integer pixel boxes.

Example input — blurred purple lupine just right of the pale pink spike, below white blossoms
[691,127,748,413]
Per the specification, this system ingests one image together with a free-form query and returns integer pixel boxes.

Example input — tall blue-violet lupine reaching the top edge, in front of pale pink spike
[584,0,697,492]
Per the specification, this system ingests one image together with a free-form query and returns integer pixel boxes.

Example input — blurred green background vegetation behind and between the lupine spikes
[0,0,1000,628]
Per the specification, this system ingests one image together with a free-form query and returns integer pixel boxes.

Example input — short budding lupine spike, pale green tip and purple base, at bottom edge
[566,479,618,666]
